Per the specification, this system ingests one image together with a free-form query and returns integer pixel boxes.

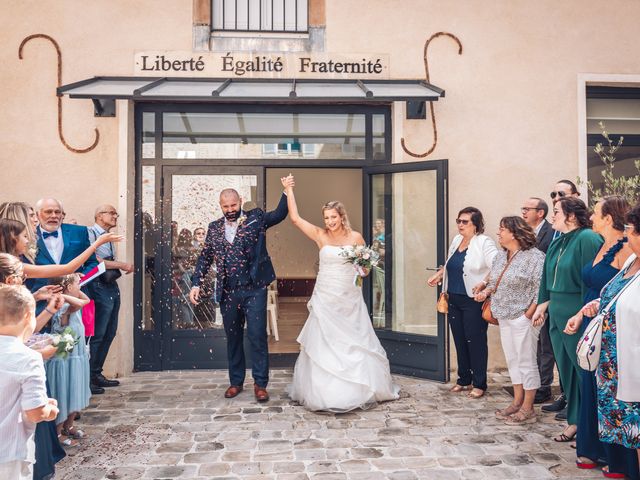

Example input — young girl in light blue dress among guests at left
[45,273,91,446]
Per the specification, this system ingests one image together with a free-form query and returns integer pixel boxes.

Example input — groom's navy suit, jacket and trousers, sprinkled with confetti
[191,194,289,388]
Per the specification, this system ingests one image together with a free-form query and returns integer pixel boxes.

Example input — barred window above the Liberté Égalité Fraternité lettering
[211,0,309,33]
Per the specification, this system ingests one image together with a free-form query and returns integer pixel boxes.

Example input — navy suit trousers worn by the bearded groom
[220,287,269,388]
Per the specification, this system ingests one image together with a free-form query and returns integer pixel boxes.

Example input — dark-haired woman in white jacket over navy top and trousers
[427,207,498,398]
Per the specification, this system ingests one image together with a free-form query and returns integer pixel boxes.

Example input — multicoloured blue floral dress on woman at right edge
[596,272,640,448]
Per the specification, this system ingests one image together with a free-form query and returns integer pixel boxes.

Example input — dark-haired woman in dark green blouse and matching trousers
[533,197,603,442]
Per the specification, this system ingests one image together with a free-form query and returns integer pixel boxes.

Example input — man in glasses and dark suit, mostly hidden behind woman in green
[520,197,555,403]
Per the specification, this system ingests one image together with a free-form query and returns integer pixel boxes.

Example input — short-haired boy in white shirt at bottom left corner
[0,286,58,480]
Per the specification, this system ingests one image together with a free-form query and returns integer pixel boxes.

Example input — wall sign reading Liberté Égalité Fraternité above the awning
[134,52,389,79]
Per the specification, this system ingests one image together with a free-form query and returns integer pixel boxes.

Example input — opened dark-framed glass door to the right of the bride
[367,161,448,380]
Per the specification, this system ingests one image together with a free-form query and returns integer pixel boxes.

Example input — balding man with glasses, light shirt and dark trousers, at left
[89,204,134,394]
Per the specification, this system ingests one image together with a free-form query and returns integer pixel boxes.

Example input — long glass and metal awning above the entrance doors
[57,77,444,105]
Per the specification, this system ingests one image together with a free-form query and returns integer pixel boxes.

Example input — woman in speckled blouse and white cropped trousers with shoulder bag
[475,217,544,425]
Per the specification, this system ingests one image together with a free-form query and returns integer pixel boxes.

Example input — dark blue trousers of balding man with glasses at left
[89,279,120,378]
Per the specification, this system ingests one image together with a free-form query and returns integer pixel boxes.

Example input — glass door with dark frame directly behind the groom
[161,167,263,369]
